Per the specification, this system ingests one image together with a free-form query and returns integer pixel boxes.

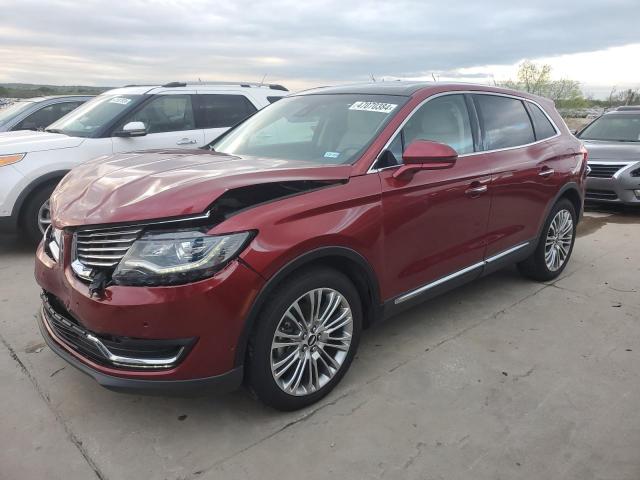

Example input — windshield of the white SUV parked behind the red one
[46,95,142,137]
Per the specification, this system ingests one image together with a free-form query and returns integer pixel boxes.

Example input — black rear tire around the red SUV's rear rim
[518,198,577,282]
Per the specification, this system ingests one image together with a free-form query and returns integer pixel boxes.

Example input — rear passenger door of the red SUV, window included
[473,93,559,263]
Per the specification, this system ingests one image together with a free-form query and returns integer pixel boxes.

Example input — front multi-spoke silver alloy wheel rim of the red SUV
[271,288,353,396]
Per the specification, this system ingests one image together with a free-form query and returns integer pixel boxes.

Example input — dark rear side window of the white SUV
[196,95,257,128]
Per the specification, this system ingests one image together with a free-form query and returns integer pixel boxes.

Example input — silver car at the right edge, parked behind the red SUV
[576,106,640,205]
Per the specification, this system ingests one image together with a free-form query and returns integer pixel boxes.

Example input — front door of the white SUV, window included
[112,91,204,153]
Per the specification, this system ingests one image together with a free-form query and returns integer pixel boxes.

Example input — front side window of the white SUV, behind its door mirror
[120,95,196,133]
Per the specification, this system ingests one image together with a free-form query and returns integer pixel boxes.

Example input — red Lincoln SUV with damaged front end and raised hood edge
[36,82,587,410]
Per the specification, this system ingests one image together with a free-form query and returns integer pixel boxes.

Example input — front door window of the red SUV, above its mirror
[402,95,473,154]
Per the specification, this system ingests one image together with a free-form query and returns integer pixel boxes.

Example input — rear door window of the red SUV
[475,95,535,150]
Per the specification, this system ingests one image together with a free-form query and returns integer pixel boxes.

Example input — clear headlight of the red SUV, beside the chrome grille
[112,230,253,285]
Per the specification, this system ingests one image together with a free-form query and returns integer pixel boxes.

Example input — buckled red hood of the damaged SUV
[51,150,351,228]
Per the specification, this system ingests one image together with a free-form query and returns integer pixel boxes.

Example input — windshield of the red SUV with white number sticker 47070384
[210,94,407,164]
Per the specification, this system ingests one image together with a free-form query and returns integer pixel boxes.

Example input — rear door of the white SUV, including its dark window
[194,92,258,144]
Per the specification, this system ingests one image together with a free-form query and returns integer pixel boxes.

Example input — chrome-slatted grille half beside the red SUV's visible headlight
[74,227,142,268]
